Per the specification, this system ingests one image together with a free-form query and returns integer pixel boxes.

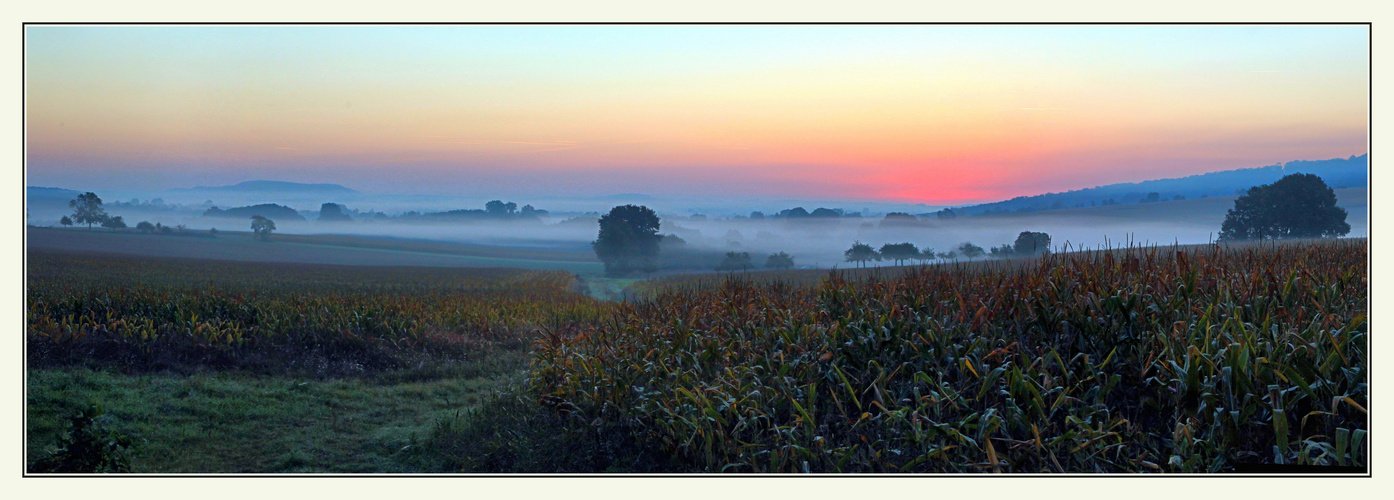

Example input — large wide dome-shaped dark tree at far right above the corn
[1220,174,1351,241]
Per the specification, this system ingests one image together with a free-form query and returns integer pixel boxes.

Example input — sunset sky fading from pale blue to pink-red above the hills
[25,25,1369,205]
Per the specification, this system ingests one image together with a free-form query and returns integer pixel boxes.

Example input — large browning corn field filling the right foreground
[530,240,1369,472]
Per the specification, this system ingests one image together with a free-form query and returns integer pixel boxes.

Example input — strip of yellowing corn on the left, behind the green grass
[25,252,606,367]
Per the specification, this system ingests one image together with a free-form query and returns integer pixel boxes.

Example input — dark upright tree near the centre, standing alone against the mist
[591,205,662,276]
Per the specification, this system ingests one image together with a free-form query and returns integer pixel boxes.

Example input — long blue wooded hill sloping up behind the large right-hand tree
[953,155,1370,214]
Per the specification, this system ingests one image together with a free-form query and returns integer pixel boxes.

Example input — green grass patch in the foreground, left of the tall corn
[26,368,517,472]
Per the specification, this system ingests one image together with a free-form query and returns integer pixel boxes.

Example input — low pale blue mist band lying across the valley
[29,179,1368,269]
